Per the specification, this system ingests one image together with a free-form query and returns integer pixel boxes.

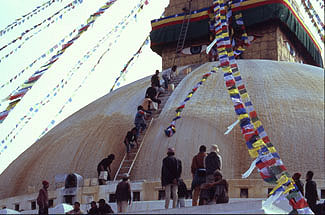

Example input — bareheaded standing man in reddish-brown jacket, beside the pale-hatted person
[191,145,206,206]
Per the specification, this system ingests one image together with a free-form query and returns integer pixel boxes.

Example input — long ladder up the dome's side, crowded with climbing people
[114,65,198,181]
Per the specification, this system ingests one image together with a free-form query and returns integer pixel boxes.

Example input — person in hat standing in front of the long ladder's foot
[115,173,131,213]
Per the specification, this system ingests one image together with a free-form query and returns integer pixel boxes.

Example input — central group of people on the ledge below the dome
[161,144,225,209]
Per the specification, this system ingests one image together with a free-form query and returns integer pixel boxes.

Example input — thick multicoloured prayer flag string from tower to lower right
[214,0,308,210]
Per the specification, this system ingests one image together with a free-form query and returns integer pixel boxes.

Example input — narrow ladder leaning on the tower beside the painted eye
[173,0,192,65]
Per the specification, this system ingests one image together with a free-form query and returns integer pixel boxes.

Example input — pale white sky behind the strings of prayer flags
[0,0,324,174]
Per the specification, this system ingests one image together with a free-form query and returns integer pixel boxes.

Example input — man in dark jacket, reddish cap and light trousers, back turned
[161,148,182,209]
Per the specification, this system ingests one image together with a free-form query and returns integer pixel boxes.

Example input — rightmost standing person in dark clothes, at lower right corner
[305,171,319,213]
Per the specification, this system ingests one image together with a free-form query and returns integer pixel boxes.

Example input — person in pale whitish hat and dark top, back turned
[205,144,222,183]
